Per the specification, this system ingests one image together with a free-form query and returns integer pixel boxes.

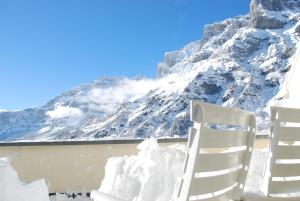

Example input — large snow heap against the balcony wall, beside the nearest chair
[99,139,185,201]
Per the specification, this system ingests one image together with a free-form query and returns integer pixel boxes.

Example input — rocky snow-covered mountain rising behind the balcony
[0,0,300,140]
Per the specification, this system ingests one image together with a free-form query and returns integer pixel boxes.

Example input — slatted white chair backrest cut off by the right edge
[265,107,300,197]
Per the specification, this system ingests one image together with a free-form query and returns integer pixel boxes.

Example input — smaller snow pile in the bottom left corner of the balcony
[0,158,49,201]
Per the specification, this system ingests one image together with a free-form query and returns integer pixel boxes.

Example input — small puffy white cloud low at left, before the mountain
[46,106,83,119]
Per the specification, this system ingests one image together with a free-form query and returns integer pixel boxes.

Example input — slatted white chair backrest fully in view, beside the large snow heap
[177,101,256,201]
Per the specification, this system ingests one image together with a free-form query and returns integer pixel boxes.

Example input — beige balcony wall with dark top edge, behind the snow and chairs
[0,138,269,193]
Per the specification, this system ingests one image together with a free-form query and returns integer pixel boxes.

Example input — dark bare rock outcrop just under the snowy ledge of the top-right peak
[252,16,286,29]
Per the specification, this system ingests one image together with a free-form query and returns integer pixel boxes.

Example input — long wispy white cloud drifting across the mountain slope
[79,75,192,113]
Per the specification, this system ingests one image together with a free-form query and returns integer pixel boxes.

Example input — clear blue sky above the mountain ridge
[0,0,250,109]
